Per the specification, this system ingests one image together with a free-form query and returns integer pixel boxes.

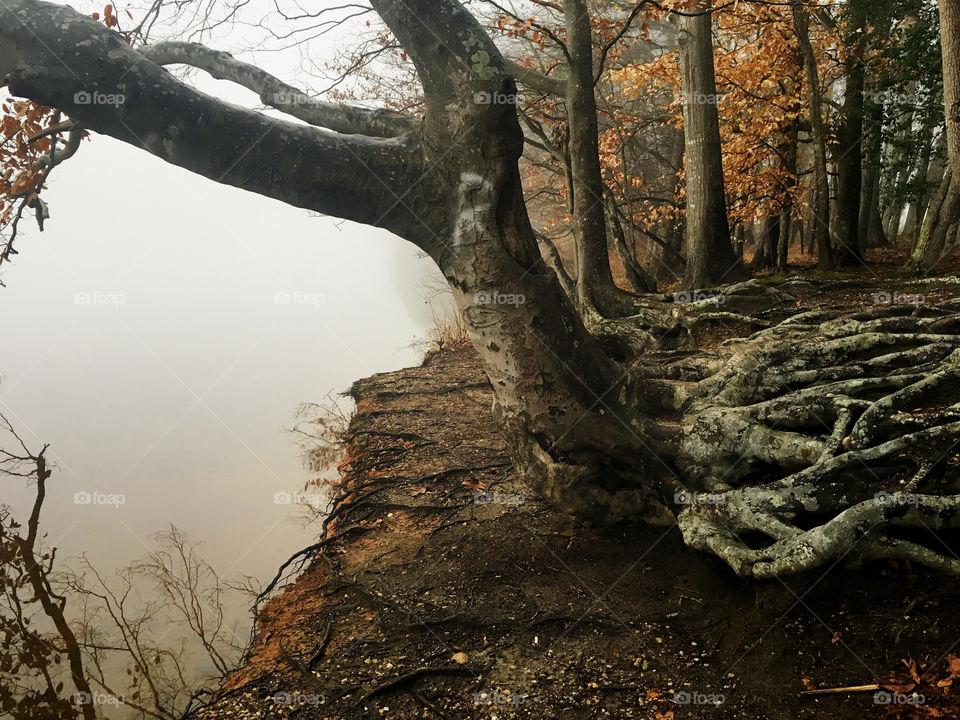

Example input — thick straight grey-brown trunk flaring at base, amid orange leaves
[679,0,745,289]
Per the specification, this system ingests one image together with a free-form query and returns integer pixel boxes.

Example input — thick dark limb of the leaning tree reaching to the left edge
[0,0,442,249]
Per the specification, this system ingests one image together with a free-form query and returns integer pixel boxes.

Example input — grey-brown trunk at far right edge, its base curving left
[910,0,960,274]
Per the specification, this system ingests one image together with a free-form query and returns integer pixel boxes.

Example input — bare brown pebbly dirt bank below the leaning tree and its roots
[198,249,960,720]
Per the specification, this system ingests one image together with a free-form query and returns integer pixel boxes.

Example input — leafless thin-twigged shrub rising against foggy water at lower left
[59,526,245,720]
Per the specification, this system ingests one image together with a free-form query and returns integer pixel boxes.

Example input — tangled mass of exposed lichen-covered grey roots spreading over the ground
[637,290,960,578]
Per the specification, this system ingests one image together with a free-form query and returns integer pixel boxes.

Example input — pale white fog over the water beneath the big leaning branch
[0,70,446,578]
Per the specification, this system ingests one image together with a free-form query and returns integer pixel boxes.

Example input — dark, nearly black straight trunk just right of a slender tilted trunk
[834,0,867,266]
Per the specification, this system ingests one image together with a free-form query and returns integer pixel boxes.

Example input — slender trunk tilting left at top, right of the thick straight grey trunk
[793,3,833,270]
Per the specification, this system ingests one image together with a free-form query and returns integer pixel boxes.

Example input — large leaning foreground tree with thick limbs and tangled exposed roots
[0,0,960,577]
